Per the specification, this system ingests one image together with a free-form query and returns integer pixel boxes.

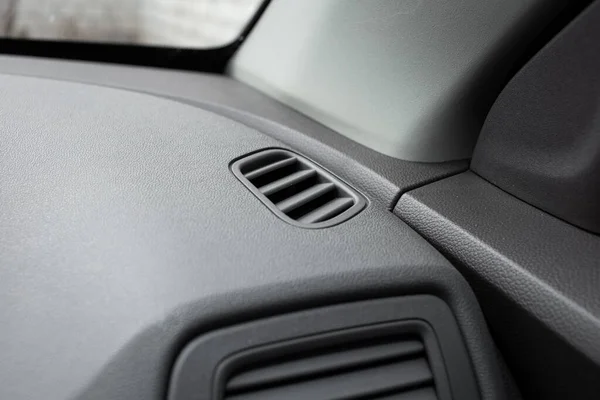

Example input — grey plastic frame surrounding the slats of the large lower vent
[168,295,480,400]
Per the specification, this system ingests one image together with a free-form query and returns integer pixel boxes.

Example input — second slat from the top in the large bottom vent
[226,359,433,400]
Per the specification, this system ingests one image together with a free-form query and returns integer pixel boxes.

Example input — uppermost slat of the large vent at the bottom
[226,340,424,392]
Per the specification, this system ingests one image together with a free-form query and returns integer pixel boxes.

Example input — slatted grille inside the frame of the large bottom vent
[224,339,437,400]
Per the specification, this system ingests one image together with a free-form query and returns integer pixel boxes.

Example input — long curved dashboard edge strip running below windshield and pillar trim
[0,56,468,209]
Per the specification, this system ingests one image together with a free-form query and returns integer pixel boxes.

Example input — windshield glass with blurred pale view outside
[0,0,263,48]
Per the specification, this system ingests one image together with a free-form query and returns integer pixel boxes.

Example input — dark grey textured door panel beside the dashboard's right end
[395,172,600,400]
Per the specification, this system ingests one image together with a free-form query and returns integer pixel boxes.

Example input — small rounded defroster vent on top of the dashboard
[231,149,366,228]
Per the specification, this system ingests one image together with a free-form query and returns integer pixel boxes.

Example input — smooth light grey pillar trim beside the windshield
[230,0,563,162]
